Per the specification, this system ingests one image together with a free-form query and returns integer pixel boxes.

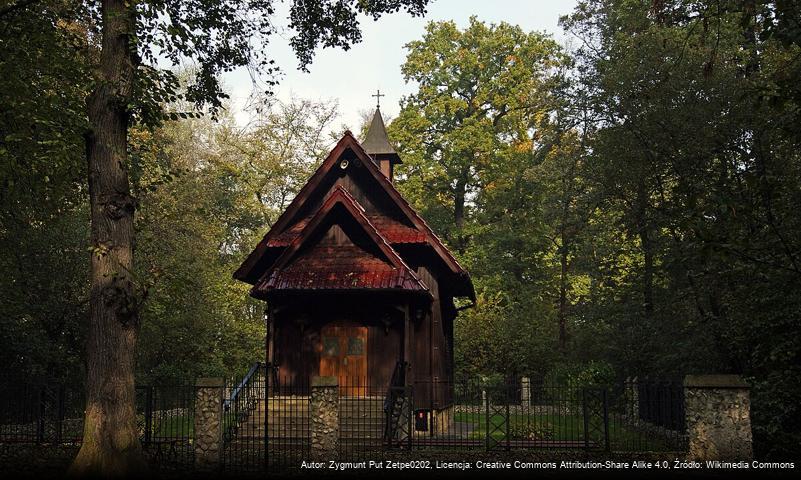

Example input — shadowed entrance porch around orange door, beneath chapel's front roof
[265,293,414,398]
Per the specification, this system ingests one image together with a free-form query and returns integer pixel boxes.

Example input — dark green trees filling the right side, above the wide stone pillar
[564,0,801,457]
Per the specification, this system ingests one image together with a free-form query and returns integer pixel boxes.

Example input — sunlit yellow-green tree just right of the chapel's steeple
[389,18,567,380]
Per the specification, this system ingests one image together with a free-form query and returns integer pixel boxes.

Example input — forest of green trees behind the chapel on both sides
[0,0,801,458]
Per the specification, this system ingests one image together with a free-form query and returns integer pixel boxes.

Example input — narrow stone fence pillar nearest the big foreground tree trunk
[195,378,224,471]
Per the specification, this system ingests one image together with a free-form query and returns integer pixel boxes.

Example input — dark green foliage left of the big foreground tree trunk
[0,1,88,378]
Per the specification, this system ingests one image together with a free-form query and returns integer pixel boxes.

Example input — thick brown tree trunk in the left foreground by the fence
[70,0,145,477]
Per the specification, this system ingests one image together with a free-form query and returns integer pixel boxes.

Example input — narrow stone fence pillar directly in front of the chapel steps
[309,377,339,461]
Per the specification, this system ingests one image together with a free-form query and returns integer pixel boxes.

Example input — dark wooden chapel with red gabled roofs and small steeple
[234,107,475,410]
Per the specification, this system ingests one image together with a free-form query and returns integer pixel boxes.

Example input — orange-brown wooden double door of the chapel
[320,321,367,396]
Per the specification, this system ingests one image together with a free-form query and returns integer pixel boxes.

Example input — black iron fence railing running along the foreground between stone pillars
[0,374,686,472]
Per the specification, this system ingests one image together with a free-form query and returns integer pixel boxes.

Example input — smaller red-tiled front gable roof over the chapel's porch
[251,186,430,297]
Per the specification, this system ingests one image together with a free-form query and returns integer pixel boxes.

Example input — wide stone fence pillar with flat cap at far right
[684,375,753,461]
